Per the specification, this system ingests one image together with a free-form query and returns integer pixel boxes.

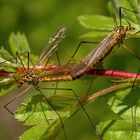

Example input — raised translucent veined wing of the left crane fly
[38,25,67,64]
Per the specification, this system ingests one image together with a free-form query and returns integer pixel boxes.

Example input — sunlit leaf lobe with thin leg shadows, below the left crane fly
[15,95,72,125]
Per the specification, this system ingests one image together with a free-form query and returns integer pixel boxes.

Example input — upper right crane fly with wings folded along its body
[72,7,140,78]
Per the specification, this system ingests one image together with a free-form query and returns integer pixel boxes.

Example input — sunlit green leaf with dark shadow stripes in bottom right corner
[98,88,140,140]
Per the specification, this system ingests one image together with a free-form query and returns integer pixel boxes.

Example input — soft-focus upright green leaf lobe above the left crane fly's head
[9,32,31,56]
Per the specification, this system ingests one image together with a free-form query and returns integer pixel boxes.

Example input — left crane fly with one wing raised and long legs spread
[4,26,101,139]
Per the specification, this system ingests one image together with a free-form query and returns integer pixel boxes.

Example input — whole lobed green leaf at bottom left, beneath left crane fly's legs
[15,95,78,140]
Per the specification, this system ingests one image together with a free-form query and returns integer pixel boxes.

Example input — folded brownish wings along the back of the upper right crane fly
[71,34,113,77]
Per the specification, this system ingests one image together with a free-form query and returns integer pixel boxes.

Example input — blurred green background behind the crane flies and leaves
[0,0,140,140]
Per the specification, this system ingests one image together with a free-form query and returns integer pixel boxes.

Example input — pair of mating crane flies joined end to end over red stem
[1,6,139,139]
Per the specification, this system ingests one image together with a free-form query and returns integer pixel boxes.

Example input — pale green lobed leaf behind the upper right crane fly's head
[78,15,140,40]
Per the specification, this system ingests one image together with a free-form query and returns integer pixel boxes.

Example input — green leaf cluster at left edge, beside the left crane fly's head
[0,32,30,96]
